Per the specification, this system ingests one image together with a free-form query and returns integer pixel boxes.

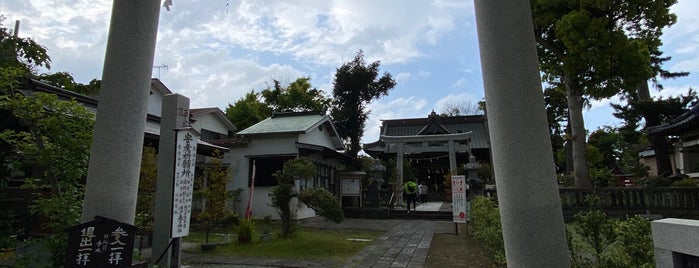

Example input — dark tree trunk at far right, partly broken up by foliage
[636,82,673,177]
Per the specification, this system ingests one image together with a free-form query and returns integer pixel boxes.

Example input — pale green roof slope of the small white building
[236,114,327,135]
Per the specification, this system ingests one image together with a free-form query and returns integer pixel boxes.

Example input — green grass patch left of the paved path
[189,228,383,261]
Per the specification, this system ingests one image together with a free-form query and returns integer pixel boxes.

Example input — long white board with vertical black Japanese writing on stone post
[170,128,199,238]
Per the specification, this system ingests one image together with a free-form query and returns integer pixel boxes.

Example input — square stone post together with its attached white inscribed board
[151,94,199,267]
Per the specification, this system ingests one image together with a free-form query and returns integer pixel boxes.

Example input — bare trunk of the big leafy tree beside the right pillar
[563,76,592,187]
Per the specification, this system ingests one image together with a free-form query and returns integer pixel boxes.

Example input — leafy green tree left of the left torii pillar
[0,92,94,266]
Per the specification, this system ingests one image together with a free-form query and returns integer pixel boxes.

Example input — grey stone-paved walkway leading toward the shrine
[183,202,454,268]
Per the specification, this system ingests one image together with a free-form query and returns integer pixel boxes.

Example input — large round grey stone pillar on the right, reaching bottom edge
[474,0,570,267]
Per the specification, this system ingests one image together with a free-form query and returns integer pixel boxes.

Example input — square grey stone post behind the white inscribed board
[151,94,189,267]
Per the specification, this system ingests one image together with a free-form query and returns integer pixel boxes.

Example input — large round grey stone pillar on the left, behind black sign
[81,0,160,224]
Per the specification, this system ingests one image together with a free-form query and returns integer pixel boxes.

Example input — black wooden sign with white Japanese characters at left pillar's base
[64,216,136,267]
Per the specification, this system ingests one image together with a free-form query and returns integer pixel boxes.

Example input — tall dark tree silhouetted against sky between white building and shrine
[330,50,396,157]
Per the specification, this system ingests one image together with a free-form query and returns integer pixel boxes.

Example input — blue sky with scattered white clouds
[0,0,699,147]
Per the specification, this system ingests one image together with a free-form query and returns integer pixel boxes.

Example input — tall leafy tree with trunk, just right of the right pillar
[531,0,676,187]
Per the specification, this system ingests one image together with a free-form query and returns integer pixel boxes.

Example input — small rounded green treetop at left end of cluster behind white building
[226,90,272,130]
